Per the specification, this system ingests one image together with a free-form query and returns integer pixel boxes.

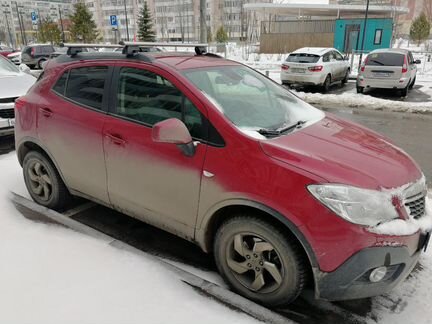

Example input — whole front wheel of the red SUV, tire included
[214,216,306,307]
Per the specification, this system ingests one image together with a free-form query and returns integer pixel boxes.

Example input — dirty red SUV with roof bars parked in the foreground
[15,44,432,307]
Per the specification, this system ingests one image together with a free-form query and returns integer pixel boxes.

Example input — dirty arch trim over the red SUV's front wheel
[197,199,318,270]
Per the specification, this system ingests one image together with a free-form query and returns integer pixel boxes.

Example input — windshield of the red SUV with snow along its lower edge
[184,65,324,133]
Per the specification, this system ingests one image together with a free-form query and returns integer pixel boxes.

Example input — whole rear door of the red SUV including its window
[37,63,113,203]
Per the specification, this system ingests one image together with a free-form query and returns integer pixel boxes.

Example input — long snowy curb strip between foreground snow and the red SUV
[10,192,295,324]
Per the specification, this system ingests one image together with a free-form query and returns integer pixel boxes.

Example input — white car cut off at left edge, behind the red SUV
[0,56,36,136]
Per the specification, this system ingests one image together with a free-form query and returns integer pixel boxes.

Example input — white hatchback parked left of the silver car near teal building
[281,47,350,91]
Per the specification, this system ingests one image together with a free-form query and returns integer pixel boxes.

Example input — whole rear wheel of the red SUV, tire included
[23,151,72,210]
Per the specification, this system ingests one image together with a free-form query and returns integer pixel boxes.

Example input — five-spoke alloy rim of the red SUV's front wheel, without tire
[226,233,284,293]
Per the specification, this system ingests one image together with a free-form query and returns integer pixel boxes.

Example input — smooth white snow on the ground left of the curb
[0,153,255,324]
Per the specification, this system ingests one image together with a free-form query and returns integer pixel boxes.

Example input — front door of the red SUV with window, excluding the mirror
[103,64,207,237]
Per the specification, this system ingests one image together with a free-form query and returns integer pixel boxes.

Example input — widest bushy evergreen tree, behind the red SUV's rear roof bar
[70,2,98,43]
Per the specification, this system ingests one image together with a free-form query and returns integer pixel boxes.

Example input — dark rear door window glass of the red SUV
[63,66,108,109]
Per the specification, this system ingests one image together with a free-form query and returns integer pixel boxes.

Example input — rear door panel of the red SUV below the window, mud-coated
[37,66,110,204]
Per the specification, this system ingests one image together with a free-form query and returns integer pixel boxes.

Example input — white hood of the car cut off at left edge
[0,72,36,98]
